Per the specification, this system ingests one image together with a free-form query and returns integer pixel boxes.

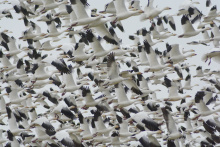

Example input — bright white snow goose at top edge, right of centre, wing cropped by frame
[140,0,171,21]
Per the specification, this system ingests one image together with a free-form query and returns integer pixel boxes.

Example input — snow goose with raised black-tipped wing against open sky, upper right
[178,15,211,38]
